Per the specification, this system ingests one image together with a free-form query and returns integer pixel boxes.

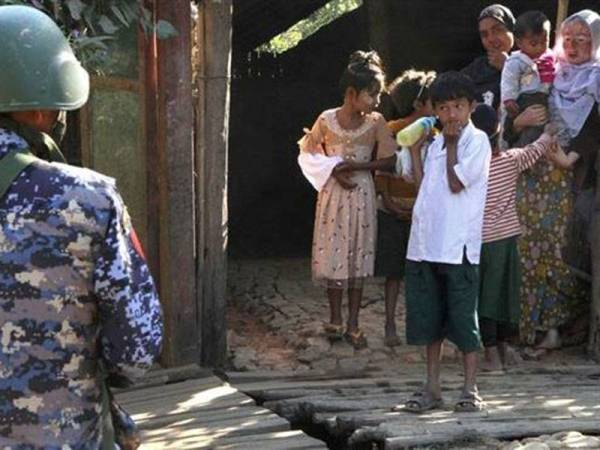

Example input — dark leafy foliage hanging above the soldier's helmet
[0,0,177,67]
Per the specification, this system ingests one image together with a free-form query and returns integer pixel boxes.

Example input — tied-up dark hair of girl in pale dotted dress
[340,50,385,95]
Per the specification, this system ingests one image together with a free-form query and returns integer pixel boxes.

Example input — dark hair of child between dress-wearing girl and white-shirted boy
[388,69,436,117]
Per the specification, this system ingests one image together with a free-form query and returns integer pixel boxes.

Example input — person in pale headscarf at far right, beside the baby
[550,10,600,348]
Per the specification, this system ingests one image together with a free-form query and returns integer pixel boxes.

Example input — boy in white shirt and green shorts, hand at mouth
[402,72,491,413]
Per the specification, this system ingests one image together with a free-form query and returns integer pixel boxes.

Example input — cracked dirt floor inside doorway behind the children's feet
[228,258,588,371]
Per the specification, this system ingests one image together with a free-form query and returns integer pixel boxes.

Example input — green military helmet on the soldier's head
[0,5,90,112]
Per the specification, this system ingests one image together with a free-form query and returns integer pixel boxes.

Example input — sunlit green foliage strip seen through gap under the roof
[257,0,363,54]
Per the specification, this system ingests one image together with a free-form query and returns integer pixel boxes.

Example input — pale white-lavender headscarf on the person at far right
[550,9,600,145]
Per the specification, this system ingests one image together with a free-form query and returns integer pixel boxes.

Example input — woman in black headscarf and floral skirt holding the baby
[462,4,573,352]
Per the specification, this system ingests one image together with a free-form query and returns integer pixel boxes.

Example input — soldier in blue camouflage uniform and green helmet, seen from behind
[0,6,162,450]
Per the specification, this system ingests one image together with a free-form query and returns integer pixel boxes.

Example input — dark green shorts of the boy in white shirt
[406,260,481,353]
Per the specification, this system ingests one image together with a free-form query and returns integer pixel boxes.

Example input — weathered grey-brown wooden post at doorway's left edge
[196,0,233,366]
